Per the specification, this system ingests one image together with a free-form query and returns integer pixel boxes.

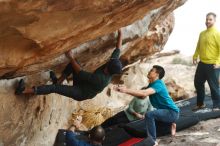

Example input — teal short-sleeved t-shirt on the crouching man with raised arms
[148,79,179,112]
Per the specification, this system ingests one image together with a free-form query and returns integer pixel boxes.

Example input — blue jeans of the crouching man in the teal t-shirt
[145,109,179,141]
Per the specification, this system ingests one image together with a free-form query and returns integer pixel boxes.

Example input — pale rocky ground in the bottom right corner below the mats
[158,118,220,146]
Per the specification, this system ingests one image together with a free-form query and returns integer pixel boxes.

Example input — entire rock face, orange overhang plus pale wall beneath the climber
[0,0,186,146]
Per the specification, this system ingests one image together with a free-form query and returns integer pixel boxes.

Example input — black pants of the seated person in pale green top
[101,111,130,128]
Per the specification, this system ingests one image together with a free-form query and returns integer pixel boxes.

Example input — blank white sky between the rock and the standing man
[164,0,220,56]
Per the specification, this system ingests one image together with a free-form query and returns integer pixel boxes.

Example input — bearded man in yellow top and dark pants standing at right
[193,12,220,110]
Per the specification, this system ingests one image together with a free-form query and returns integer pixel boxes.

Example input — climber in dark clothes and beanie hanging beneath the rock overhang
[15,29,122,101]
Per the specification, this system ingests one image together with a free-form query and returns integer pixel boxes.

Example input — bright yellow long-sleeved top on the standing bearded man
[193,26,220,64]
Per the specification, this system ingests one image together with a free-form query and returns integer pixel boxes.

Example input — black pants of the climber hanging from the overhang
[34,63,89,101]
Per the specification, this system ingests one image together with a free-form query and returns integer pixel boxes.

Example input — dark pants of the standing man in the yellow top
[194,62,220,108]
